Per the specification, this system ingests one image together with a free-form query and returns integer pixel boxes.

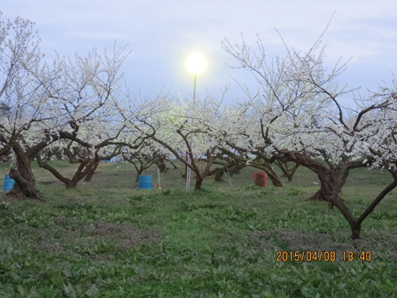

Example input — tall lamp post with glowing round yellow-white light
[186,52,207,189]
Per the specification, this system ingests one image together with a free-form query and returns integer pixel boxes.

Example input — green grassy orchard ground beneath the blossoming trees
[0,162,397,298]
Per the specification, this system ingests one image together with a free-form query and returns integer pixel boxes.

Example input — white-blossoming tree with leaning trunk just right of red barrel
[222,33,334,186]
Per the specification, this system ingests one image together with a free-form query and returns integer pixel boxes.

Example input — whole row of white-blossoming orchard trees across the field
[0,16,397,239]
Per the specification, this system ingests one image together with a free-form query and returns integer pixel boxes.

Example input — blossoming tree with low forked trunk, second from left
[33,47,145,187]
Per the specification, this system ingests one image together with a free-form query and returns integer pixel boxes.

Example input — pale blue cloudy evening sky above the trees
[0,0,397,105]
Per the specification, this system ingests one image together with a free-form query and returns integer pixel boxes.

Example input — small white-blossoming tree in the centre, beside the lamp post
[145,97,229,190]
